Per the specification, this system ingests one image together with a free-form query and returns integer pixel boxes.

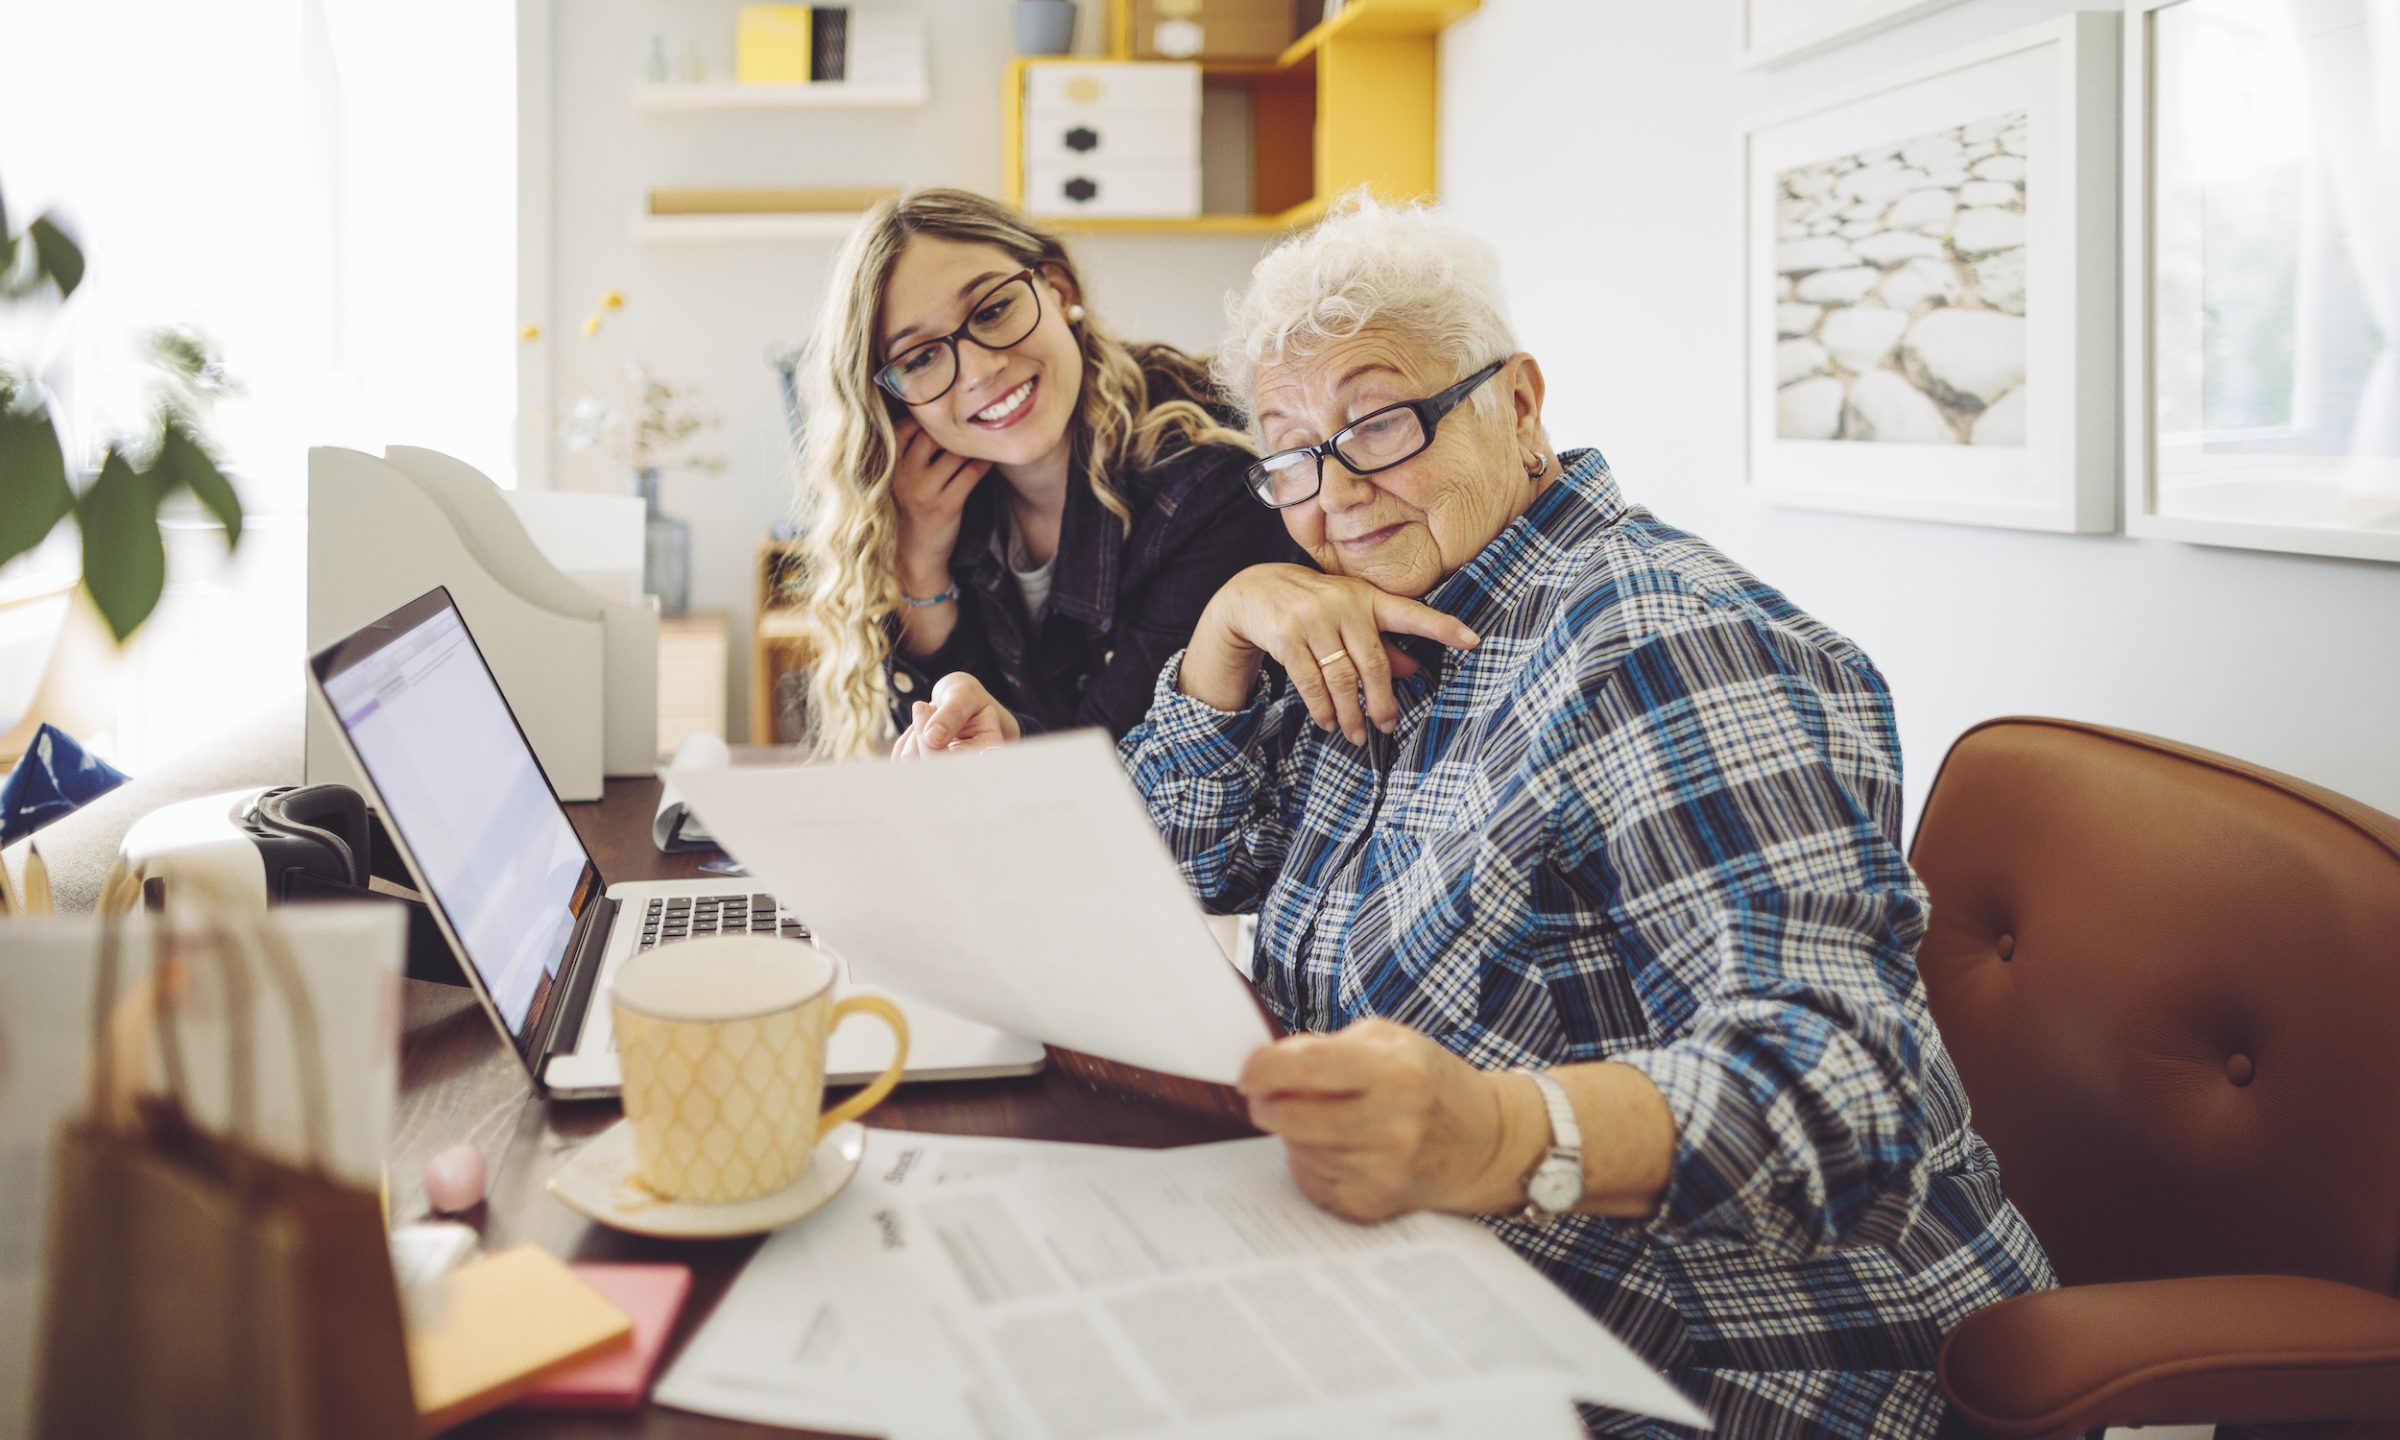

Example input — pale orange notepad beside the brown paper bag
[408,1246,634,1435]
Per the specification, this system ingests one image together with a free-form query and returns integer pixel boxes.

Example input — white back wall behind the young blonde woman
[526,0,1262,739]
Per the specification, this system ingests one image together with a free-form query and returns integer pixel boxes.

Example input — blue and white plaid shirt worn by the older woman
[1123,451,2054,1438]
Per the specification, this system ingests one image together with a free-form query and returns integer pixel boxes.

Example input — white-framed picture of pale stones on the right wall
[1742,14,2119,533]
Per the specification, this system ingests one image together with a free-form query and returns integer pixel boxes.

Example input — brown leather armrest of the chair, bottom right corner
[1939,1274,2400,1440]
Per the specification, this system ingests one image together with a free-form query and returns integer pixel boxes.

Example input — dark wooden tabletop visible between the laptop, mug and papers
[391,780,1258,1438]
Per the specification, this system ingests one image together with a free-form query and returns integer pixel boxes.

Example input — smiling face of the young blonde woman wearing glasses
[876,235,1082,466]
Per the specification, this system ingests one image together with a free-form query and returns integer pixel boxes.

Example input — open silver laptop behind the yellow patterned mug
[310,588,1044,1099]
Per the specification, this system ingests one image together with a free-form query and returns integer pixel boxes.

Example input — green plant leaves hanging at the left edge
[0,182,242,641]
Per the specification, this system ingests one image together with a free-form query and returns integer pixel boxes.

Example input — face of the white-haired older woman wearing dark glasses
[1250,329,1555,598]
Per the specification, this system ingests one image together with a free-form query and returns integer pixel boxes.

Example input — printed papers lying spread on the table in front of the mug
[655,1130,1706,1440]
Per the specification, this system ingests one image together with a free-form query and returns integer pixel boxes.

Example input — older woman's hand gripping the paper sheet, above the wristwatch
[1238,1020,1507,1224]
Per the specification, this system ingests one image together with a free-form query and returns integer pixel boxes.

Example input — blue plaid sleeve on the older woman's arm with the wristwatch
[1558,617,1927,1258]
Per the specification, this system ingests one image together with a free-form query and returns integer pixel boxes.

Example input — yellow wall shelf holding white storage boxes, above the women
[1001,0,1481,235]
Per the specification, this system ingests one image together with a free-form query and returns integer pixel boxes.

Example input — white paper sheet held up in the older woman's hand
[665,730,1267,1085]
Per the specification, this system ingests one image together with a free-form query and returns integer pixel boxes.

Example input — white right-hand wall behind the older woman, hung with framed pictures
[1442,0,2400,823]
